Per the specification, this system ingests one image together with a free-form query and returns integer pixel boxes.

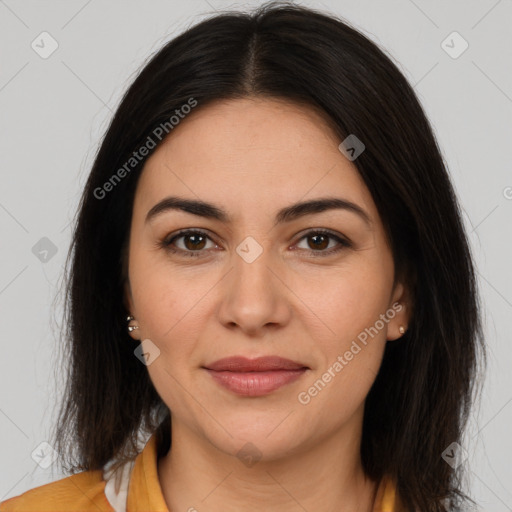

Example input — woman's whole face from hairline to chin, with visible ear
[126,98,408,460]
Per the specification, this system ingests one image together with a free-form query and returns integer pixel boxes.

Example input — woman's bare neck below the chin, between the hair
[158,421,377,512]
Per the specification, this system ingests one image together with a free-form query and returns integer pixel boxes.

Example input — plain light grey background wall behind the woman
[0,0,512,512]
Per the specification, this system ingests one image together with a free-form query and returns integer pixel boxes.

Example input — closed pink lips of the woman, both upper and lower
[203,356,309,397]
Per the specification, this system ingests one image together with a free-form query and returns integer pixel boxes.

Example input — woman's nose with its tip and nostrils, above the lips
[218,242,293,338]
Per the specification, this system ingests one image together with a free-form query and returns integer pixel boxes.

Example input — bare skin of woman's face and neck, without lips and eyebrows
[126,97,410,512]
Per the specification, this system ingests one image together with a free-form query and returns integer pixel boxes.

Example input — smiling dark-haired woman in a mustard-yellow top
[0,4,484,512]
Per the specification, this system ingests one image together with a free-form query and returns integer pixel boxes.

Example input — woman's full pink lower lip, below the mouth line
[207,368,306,396]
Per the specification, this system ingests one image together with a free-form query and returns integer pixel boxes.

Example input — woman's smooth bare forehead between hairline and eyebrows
[136,98,376,222]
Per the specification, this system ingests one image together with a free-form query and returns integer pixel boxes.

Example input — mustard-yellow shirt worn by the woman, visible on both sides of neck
[0,435,402,512]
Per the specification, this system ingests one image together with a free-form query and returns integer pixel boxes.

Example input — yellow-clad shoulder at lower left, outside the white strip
[0,470,114,512]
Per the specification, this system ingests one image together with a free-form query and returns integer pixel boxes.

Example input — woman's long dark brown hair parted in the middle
[50,3,485,512]
